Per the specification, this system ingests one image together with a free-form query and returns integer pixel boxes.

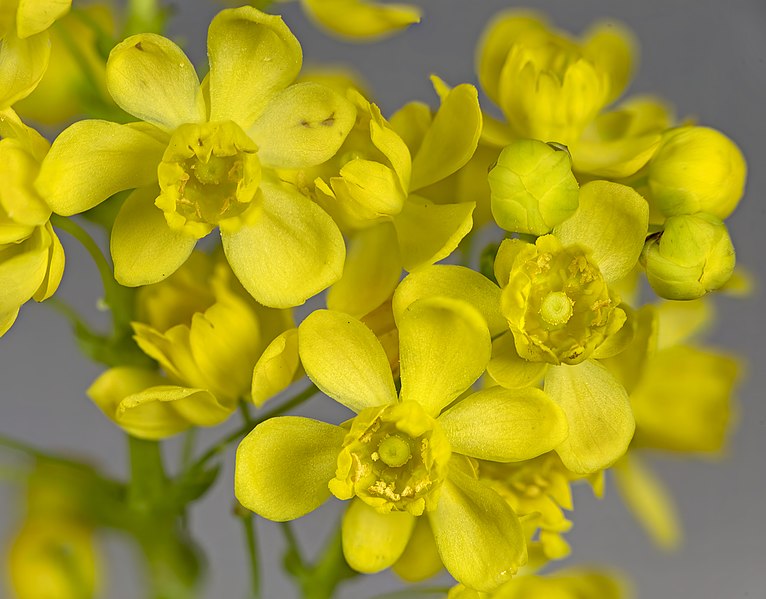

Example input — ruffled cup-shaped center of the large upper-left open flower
[156,121,261,237]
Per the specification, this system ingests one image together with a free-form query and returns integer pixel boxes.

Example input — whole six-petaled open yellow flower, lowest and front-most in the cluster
[235,298,566,590]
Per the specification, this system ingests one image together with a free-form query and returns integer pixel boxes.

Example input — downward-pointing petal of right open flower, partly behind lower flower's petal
[544,360,636,474]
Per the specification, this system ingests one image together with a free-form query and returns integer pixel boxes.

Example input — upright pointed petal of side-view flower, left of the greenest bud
[410,83,482,191]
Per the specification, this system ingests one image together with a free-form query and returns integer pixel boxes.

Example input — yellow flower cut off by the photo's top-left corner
[0,0,72,109]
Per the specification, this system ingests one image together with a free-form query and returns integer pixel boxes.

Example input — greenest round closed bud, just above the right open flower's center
[489,139,579,235]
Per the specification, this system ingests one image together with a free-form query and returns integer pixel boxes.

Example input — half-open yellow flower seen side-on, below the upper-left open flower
[88,252,292,439]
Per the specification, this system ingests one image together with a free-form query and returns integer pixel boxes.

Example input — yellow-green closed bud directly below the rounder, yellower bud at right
[641,212,735,300]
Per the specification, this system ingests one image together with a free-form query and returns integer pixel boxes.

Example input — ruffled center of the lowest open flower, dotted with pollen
[329,401,452,516]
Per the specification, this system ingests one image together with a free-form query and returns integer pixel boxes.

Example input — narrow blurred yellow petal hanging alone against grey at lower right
[614,456,681,549]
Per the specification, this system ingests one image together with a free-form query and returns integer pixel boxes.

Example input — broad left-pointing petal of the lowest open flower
[234,416,346,522]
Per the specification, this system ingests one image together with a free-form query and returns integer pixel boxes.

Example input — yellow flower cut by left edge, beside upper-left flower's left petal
[0,109,64,337]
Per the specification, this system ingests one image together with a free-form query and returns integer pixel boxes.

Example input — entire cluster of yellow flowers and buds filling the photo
[0,0,746,599]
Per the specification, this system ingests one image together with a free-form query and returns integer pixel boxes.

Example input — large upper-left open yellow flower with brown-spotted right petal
[37,7,356,308]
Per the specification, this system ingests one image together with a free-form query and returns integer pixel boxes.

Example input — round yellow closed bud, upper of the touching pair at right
[648,127,747,219]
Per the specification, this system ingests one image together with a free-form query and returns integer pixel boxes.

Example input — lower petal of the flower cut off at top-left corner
[0,31,51,108]
